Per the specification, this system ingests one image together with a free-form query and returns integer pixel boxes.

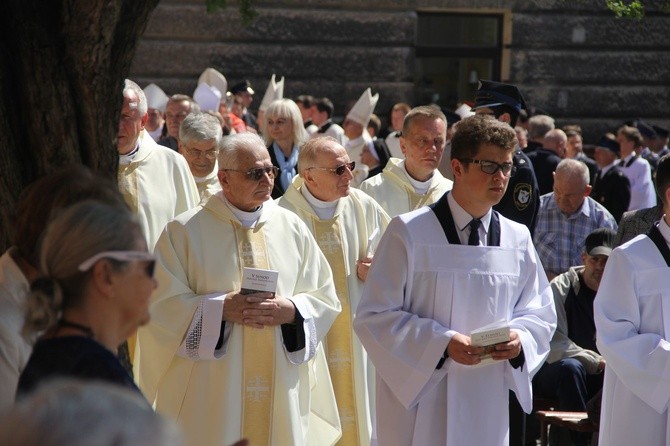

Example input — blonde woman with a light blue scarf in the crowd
[262,99,309,198]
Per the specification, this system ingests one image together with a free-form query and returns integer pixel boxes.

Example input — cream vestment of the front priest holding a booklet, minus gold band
[136,194,340,445]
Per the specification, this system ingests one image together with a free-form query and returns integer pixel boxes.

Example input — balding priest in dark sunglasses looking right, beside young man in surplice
[279,137,389,445]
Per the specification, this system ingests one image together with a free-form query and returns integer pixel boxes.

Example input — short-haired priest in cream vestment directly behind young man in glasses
[361,106,453,221]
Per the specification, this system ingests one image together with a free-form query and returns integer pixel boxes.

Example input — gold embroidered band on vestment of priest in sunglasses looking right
[313,218,359,446]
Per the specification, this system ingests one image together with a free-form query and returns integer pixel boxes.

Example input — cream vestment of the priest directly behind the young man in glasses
[360,158,454,218]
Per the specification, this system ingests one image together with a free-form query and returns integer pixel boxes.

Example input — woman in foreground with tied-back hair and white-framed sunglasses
[17,201,157,397]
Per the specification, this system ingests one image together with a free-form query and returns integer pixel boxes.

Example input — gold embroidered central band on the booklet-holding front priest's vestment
[234,222,275,445]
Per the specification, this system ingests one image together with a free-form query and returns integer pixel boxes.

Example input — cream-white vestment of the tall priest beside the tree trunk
[119,130,200,250]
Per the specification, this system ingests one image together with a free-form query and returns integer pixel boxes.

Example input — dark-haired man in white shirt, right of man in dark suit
[616,125,656,211]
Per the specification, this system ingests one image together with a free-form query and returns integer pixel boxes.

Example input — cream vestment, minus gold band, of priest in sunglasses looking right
[278,177,389,445]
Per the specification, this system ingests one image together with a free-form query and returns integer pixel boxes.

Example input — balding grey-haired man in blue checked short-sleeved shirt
[533,158,617,280]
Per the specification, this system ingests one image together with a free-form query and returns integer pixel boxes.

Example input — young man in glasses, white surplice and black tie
[354,116,556,446]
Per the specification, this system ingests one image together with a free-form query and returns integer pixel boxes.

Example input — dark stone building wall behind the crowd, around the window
[131,0,670,142]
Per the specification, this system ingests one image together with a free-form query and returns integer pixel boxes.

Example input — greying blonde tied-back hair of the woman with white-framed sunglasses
[23,200,142,337]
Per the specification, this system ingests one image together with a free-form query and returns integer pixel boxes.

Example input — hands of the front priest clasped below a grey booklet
[223,291,295,328]
